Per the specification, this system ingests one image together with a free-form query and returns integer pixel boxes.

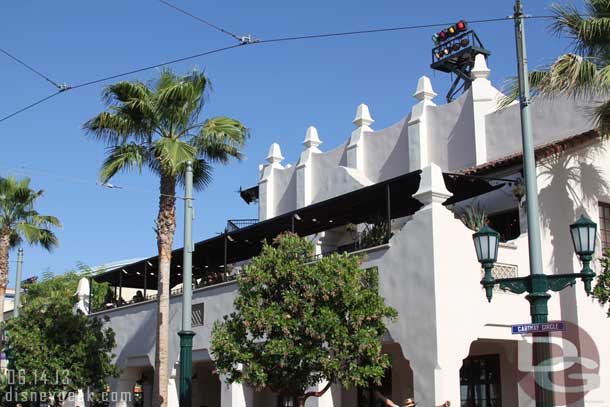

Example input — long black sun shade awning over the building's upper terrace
[94,171,501,290]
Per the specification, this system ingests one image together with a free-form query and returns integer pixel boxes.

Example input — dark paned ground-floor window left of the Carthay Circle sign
[460,355,502,407]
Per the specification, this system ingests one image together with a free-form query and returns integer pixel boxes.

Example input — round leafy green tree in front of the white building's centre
[211,234,397,406]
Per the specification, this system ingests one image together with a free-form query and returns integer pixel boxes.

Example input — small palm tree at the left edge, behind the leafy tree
[0,177,61,322]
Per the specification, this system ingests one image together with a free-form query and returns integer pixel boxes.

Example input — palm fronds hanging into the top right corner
[502,0,610,133]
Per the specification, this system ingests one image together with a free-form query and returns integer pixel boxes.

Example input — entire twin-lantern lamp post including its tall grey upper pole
[473,0,597,407]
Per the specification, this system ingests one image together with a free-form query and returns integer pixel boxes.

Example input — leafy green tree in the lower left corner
[3,271,119,402]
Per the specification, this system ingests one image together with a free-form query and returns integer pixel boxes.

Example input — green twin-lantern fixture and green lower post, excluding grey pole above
[472,215,597,407]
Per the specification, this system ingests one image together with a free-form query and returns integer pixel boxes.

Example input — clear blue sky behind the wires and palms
[0,0,578,286]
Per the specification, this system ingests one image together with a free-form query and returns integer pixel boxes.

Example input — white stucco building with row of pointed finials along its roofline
[94,56,610,407]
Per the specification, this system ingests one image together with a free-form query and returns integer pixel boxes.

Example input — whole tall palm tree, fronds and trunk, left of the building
[83,69,248,407]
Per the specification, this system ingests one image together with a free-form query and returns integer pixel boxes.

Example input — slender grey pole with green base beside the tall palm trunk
[178,161,195,407]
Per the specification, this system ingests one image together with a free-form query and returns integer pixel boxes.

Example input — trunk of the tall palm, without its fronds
[153,175,176,407]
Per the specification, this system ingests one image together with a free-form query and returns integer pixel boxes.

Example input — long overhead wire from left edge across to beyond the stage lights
[0,16,553,123]
